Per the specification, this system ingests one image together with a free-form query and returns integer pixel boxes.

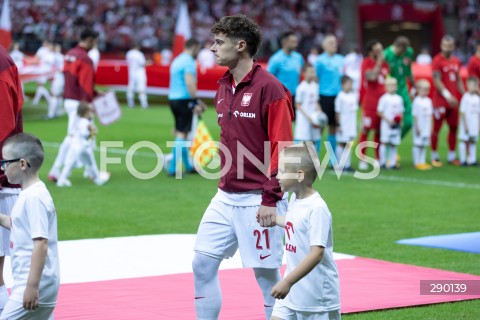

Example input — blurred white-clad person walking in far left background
[32,40,55,106]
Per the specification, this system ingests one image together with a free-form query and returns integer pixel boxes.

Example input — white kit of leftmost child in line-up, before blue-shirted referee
[293,81,321,141]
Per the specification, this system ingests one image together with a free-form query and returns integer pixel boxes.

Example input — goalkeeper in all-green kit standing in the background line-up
[384,36,415,139]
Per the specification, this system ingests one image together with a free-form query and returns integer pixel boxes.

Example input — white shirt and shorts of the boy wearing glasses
[0,181,60,319]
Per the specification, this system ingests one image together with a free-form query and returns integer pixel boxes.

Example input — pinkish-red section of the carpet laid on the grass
[55,258,480,320]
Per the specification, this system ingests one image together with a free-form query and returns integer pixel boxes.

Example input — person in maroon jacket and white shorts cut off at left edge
[0,46,23,312]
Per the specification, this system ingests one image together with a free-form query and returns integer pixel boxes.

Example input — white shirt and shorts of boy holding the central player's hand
[273,192,340,319]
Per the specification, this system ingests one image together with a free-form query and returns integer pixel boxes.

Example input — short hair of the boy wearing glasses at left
[3,133,45,172]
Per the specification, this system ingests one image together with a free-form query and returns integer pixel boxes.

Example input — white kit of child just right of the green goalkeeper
[412,96,433,147]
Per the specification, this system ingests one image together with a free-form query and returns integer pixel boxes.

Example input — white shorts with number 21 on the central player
[195,190,288,269]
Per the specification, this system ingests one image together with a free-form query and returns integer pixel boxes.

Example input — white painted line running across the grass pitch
[43,142,480,190]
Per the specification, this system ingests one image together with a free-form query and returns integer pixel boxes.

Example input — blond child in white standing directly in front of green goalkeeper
[377,78,404,169]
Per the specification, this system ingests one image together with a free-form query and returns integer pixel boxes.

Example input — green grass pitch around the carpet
[20,85,480,320]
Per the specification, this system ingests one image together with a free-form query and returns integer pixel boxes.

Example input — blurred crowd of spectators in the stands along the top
[11,0,343,57]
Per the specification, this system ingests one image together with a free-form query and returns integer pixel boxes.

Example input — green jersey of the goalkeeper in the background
[384,45,414,95]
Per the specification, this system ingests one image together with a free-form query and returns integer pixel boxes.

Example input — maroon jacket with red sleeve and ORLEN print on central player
[215,64,294,207]
